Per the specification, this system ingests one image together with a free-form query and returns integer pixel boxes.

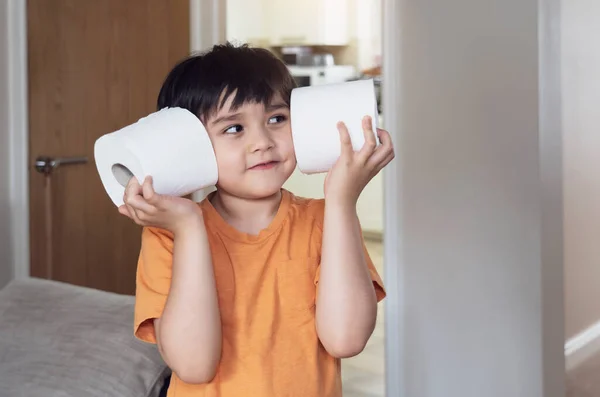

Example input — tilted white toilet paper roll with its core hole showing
[94,108,218,206]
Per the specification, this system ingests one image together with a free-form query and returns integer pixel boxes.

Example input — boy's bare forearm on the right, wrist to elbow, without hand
[316,201,377,357]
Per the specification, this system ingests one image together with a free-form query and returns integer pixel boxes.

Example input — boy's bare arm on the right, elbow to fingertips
[316,117,394,357]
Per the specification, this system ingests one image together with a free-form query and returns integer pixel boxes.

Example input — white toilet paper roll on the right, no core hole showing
[290,79,379,174]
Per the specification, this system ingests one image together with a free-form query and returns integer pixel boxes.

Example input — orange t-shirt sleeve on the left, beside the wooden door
[134,227,173,343]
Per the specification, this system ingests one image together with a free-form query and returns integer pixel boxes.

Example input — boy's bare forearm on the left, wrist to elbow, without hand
[157,218,221,383]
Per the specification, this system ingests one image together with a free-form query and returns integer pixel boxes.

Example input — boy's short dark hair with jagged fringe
[157,42,296,121]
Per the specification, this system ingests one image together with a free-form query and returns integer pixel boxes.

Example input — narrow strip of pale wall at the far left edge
[0,1,13,288]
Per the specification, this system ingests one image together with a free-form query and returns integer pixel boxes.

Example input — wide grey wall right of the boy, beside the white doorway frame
[384,0,564,397]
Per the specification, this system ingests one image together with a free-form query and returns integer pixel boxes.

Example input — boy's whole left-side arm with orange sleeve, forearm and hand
[126,177,221,383]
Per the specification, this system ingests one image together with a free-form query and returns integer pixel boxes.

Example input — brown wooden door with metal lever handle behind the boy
[27,0,190,294]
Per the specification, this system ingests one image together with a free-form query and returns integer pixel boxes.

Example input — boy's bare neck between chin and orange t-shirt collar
[210,190,282,235]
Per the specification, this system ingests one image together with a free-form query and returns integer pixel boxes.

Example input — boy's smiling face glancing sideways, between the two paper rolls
[204,93,296,199]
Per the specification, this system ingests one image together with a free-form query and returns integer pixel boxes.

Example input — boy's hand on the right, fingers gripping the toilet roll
[324,116,395,205]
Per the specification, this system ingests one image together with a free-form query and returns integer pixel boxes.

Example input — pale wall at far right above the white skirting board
[562,0,600,337]
